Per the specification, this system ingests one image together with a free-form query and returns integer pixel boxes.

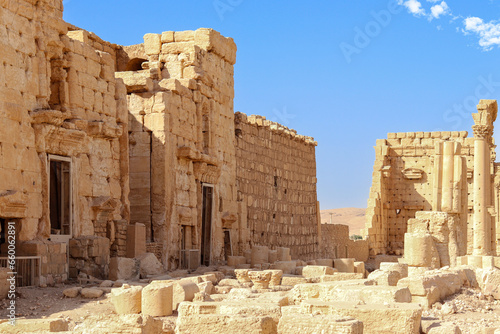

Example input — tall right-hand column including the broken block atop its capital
[472,100,497,255]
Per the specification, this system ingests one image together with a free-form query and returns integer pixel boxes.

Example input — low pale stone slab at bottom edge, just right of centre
[278,314,363,334]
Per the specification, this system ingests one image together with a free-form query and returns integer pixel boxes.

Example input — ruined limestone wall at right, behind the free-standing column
[364,131,495,256]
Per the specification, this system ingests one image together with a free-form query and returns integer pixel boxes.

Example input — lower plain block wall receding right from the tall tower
[235,113,319,259]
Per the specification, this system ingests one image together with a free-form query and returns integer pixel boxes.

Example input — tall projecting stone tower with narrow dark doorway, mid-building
[122,29,237,268]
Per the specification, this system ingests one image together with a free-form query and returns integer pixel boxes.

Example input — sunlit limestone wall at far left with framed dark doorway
[0,0,129,282]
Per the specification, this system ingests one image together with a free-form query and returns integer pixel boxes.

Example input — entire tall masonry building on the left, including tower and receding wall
[0,0,320,284]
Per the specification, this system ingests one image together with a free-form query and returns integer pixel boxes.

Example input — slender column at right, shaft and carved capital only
[472,125,492,255]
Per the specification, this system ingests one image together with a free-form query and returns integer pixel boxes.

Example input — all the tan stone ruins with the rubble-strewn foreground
[0,0,500,334]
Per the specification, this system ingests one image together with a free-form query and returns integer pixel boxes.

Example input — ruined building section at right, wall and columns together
[365,100,500,264]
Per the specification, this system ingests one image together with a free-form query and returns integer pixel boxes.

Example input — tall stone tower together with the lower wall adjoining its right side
[116,29,319,268]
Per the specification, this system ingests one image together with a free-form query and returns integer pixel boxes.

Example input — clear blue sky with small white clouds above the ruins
[64,0,500,209]
